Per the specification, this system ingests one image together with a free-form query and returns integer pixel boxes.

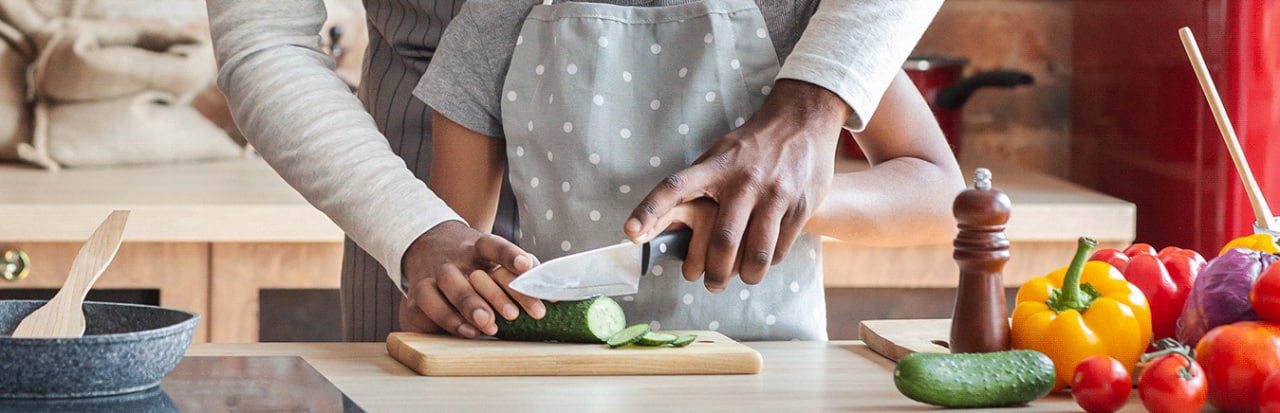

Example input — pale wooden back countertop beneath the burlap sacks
[0,157,343,242]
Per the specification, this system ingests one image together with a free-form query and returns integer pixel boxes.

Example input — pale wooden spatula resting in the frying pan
[13,211,129,338]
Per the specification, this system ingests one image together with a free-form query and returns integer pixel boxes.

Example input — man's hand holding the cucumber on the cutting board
[399,221,547,339]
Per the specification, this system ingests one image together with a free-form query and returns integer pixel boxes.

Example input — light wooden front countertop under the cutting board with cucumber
[187,341,1142,413]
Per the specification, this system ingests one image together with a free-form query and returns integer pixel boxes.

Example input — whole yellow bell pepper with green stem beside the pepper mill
[1010,238,1151,391]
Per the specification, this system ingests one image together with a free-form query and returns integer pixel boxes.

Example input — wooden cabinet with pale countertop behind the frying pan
[0,159,342,343]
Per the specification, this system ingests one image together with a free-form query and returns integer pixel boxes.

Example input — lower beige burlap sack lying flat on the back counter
[23,92,241,169]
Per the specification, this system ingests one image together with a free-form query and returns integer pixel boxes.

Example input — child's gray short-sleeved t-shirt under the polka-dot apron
[413,0,819,137]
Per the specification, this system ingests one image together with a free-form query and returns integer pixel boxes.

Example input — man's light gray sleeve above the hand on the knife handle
[778,0,942,130]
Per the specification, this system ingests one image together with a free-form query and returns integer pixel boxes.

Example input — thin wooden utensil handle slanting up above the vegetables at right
[1178,27,1280,233]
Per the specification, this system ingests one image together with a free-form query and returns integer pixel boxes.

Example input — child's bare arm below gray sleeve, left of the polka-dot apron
[428,113,506,233]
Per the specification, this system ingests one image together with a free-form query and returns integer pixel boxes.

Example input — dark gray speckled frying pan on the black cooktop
[0,300,200,399]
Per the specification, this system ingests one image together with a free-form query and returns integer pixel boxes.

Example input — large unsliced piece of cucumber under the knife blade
[494,297,627,344]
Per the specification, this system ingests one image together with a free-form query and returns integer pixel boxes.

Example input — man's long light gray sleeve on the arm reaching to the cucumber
[207,0,458,281]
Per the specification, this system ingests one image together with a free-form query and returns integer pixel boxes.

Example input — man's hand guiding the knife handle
[623,81,851,292]
